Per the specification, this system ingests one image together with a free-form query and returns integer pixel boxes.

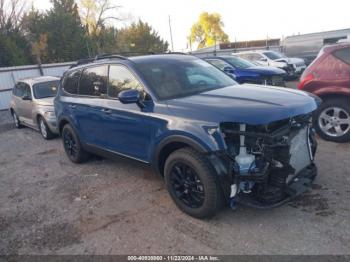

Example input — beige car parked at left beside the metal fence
[10,76,60,139]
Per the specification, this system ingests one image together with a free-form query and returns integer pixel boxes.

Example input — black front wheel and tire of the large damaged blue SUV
[164,148,224,218]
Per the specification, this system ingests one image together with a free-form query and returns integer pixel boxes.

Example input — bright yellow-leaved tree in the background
[189,12,229,48]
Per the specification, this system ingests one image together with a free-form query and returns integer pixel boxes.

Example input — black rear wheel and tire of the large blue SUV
[62,124,90,164]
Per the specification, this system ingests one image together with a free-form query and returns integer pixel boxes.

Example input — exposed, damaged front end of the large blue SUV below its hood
[220,114,317,208]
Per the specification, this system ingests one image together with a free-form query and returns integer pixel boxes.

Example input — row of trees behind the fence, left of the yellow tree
[0,0,168,66]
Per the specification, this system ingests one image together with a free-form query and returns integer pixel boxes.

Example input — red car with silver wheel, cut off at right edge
[298,42,350,142]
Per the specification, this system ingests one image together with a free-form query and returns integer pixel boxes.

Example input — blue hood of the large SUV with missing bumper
[168,84,320,125]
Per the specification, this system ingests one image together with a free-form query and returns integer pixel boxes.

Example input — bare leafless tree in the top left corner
[0,0,28,29]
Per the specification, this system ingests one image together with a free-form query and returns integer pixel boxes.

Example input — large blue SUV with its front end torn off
[55,54,320,218]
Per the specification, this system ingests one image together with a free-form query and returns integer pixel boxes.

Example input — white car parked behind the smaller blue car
[233,50,306,78]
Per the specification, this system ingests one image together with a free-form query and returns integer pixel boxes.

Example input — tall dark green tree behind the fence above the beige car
[23,0,88,63]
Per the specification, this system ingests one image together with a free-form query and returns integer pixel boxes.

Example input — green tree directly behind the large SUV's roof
[117,20,169,53]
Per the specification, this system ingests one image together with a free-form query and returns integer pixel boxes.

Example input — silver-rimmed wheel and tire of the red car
[313,99,350,143]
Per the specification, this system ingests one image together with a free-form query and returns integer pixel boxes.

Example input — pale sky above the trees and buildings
[34,0,350,51]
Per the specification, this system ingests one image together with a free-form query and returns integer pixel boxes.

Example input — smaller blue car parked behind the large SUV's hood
[204,56,286,86]
